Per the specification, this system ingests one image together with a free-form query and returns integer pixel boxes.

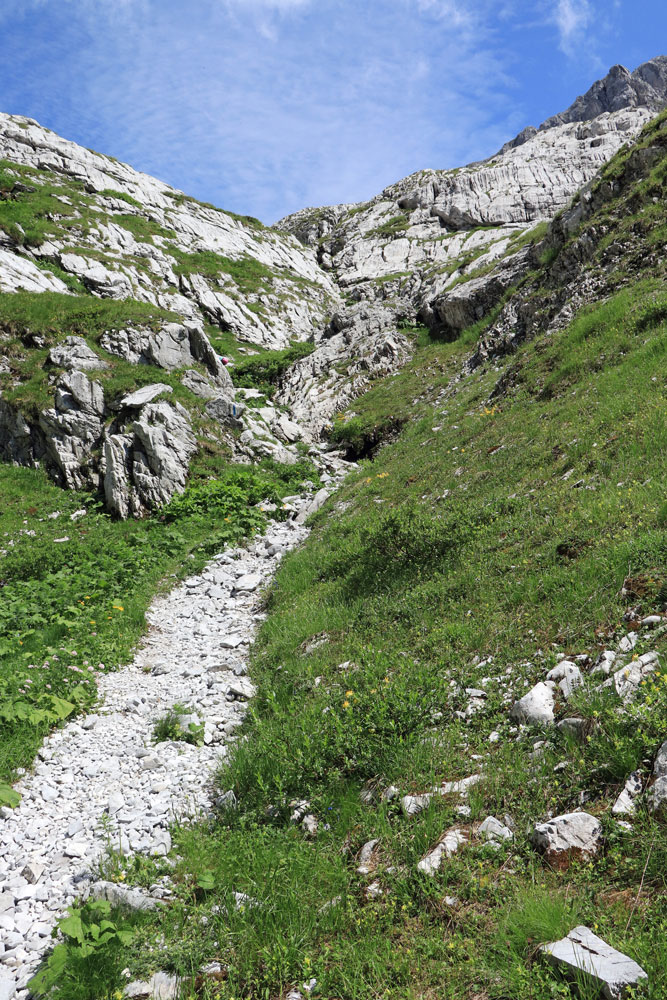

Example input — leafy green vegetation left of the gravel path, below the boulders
[0,459,313,788]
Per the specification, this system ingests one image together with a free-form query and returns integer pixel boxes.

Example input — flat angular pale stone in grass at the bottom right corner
[540,925,648,1000]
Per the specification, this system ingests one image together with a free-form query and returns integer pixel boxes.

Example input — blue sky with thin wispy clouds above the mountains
[0,0,667,222]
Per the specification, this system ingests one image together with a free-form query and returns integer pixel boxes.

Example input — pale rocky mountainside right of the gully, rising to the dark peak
[278,57,667,434]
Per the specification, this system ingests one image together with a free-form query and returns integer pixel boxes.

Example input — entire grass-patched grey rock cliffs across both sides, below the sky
[0,57,667,517]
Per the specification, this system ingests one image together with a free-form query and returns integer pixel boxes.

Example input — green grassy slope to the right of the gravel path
[81,282,667,1000]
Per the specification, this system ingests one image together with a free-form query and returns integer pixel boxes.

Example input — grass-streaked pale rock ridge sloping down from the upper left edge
[0,114,338,348]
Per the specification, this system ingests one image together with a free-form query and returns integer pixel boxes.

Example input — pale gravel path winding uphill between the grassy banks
[0,500,324,1000]
